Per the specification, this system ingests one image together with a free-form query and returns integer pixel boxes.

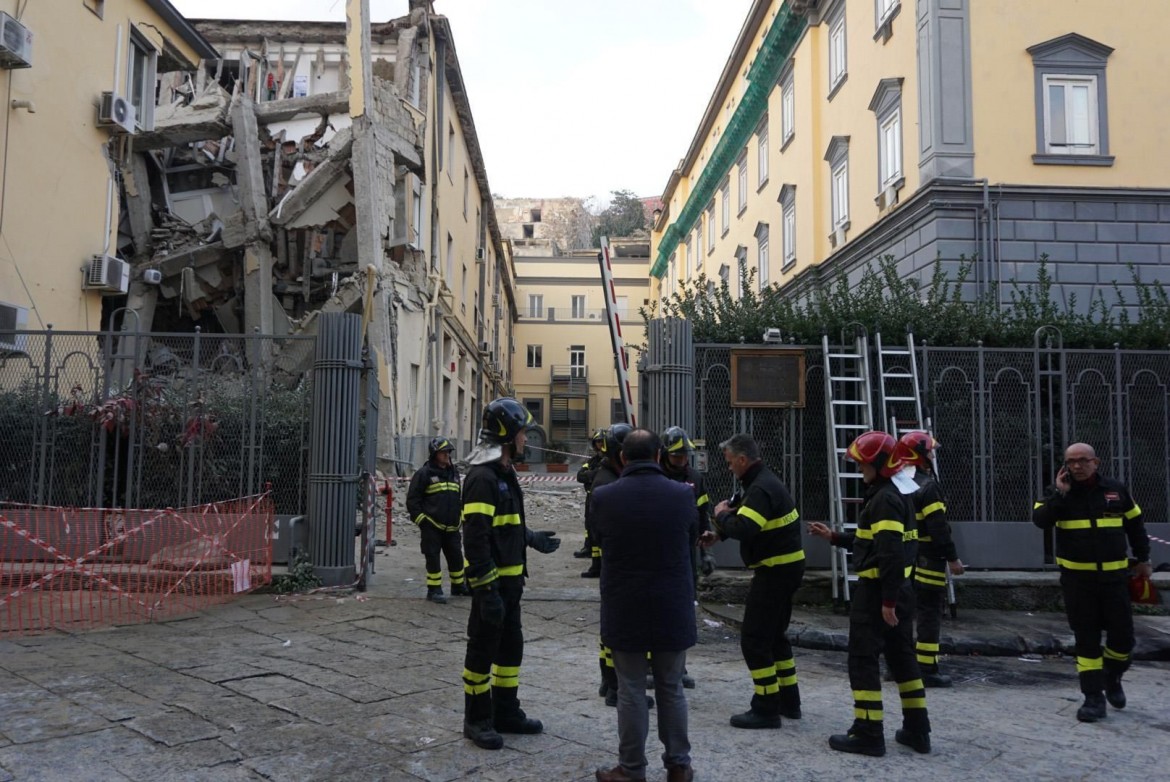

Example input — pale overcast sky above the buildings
[172,0,751,201]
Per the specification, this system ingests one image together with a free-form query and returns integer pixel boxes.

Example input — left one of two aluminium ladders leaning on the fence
[821,327,874,602]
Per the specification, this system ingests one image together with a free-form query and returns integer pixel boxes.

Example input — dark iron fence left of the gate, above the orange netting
[0,329,314,514]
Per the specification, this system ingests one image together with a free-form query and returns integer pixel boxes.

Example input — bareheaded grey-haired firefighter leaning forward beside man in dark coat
[702,434,805,728]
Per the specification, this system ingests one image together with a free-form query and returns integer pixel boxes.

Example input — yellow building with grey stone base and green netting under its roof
[652,0,1170,313]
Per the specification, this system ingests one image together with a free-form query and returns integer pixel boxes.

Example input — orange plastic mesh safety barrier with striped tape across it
[0,493,274,637]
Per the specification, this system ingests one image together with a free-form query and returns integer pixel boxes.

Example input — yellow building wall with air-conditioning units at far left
[0,0,216,339]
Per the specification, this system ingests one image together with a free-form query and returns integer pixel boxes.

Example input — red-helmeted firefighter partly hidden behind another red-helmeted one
[900,432,964,687]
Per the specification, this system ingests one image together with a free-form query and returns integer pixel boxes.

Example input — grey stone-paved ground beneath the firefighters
[0,479,1170,782]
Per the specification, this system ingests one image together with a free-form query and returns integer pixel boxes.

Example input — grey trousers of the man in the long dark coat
[613,649,690,778]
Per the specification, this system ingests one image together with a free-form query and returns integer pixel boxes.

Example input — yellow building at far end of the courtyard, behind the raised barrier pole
[511,239,649,453]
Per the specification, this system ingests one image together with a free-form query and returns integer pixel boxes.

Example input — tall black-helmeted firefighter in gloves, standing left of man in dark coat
[463,397,560,749]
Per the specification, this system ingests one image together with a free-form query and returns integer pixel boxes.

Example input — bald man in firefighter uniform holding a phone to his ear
[1032,443,1151,722]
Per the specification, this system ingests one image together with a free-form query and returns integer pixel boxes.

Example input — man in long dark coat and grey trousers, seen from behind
[592,428,698,782]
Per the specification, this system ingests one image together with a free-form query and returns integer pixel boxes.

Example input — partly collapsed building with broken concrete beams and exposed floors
[0,0,515,468]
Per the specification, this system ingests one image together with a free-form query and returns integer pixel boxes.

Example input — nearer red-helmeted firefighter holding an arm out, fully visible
[808,432,930,756]
